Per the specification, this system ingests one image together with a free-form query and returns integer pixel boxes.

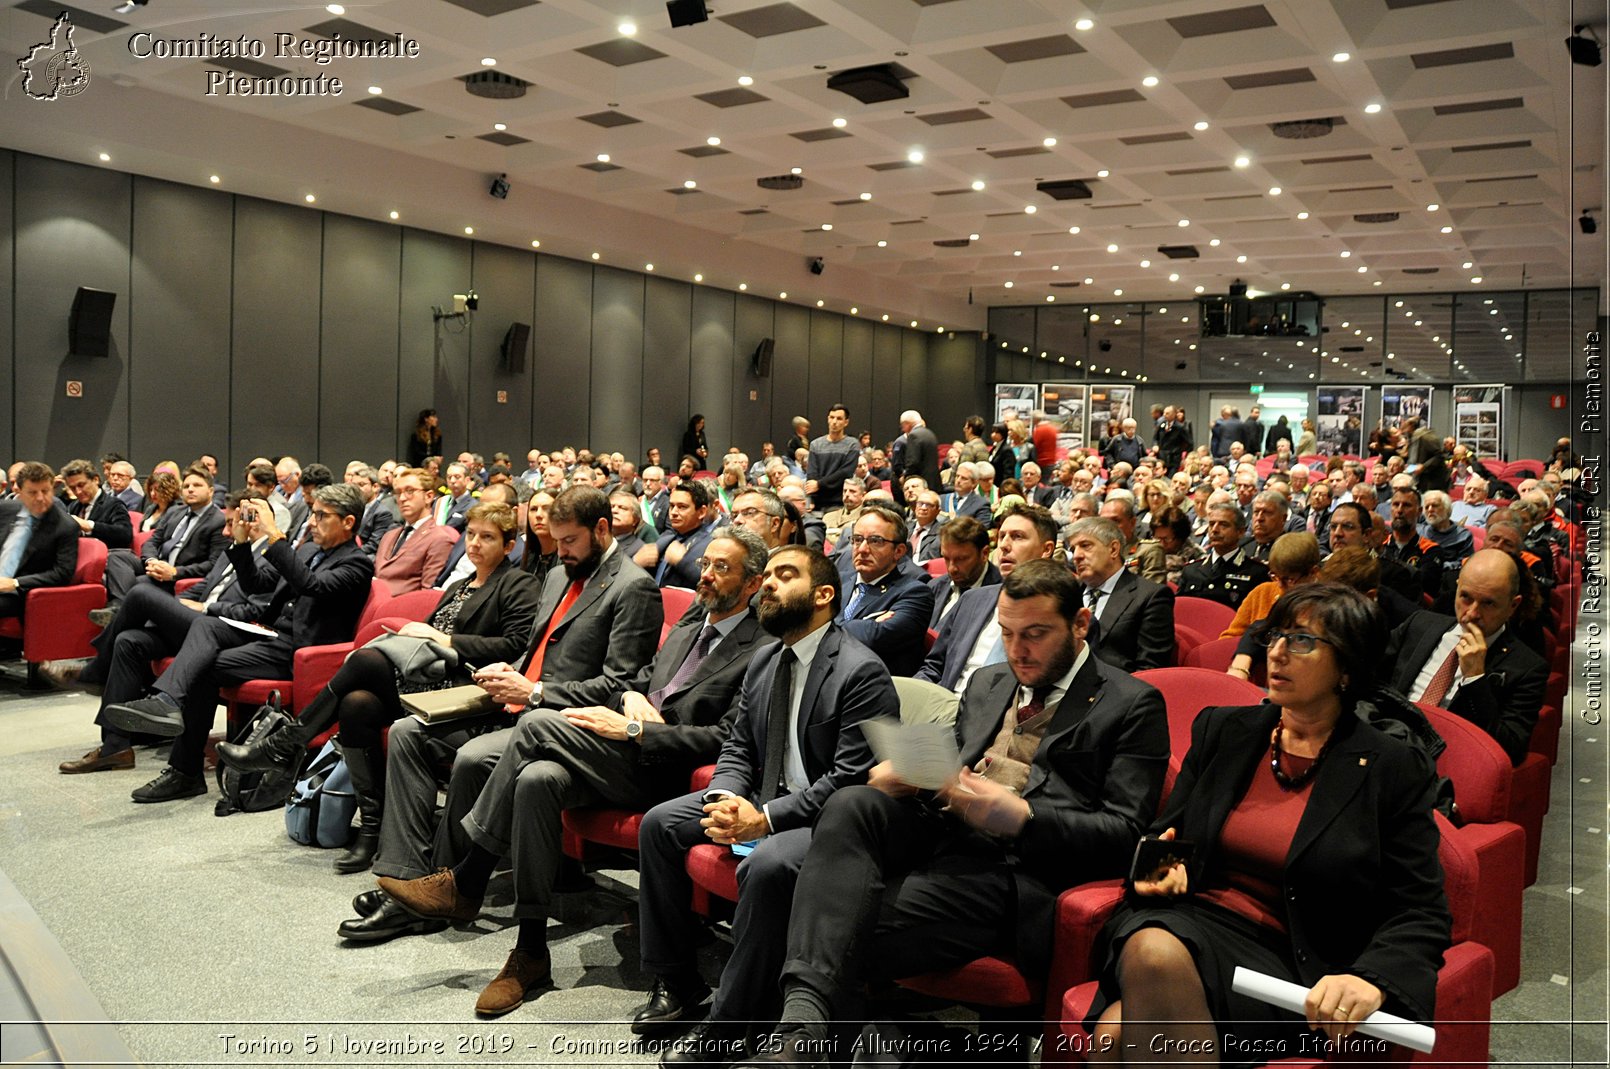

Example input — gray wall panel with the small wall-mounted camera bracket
[397,227,470,462]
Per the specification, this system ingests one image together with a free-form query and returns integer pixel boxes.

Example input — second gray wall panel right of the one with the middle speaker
[586,267,644,457]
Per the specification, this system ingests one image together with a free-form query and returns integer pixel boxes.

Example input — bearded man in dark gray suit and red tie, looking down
[340,486,665,942]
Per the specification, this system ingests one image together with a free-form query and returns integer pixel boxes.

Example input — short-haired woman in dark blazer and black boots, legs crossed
[219,504,541,873]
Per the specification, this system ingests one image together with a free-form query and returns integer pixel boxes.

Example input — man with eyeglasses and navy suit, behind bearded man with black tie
[840,504,934,676]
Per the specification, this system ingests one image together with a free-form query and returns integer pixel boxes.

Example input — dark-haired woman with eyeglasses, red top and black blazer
[1090,583,1451,1064]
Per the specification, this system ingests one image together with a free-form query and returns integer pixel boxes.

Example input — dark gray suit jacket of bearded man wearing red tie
[522,551,665,708]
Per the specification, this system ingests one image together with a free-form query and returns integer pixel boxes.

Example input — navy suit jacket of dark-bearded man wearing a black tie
[710,623,900,831]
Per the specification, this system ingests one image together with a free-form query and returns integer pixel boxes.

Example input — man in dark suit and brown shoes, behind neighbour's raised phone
[58,492,274,776]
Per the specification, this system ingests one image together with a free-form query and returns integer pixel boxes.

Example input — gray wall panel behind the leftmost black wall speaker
[13,156,129,470]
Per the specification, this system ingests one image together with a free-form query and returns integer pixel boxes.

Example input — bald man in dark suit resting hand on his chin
[1383,549,1549,765]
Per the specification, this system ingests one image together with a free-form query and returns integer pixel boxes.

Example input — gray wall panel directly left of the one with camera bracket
[317,216,399,475]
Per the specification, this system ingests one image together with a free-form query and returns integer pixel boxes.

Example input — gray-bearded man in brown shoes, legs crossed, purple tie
[364,526,766,1016]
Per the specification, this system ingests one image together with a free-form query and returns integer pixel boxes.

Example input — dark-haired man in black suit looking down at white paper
[753,560,1169,1066]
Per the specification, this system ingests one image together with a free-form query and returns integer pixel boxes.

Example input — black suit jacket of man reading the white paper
[956,657,1169,972]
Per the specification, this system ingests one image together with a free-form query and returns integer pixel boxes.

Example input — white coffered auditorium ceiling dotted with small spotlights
[0,0,1607,338]
